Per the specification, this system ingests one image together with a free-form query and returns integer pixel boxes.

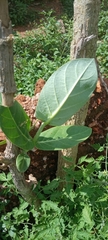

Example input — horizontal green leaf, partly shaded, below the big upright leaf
[35,126,92,150]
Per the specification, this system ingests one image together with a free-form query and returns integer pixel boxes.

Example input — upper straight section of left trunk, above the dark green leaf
[0,0,16,106]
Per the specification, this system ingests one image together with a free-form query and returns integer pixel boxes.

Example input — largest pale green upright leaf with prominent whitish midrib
[36,58,97,126]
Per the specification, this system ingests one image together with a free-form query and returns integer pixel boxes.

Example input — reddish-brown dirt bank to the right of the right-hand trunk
[78,79,108,162]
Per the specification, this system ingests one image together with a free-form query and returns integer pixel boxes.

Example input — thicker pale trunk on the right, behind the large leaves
[57,0,100,187]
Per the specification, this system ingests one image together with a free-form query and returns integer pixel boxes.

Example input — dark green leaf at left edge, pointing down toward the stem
[0,101,34,151]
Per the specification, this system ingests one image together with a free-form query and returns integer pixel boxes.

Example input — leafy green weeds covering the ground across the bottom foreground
[0,150,108,240]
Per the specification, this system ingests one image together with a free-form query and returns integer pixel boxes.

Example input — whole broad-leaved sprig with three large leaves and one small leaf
[0,58,97,172]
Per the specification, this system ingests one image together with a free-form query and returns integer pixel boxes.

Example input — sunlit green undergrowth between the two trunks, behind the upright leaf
[14,12,72,96]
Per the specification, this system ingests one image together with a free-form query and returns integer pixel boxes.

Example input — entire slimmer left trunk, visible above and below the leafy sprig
[0,0,40,209]
